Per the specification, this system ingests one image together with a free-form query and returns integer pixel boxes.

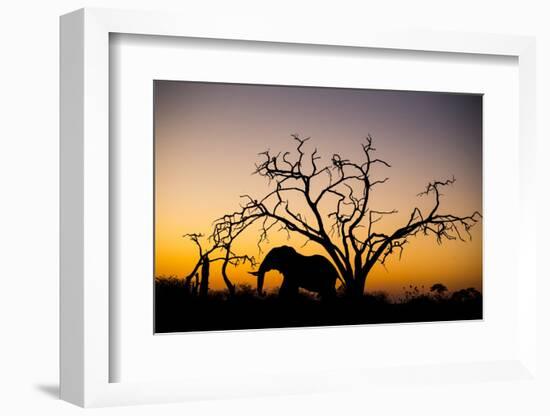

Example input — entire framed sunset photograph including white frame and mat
[61,9,542,414]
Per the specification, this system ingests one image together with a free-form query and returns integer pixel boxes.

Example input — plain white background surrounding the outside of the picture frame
[0,0,550,415]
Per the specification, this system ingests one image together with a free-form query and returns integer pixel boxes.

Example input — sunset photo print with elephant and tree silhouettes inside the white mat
[154,80,483,333]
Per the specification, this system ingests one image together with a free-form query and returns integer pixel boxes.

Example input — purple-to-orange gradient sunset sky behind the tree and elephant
[155,81,482,295]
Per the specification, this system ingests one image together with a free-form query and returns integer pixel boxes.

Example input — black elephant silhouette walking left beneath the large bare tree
[250,246,338,299]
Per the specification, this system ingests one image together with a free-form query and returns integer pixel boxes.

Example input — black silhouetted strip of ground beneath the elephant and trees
[155,279,482,333]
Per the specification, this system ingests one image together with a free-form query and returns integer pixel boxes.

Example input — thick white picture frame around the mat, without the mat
[60,9,540,407]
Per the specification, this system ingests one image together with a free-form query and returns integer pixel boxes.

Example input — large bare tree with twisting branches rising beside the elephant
[212,135,481,295]
